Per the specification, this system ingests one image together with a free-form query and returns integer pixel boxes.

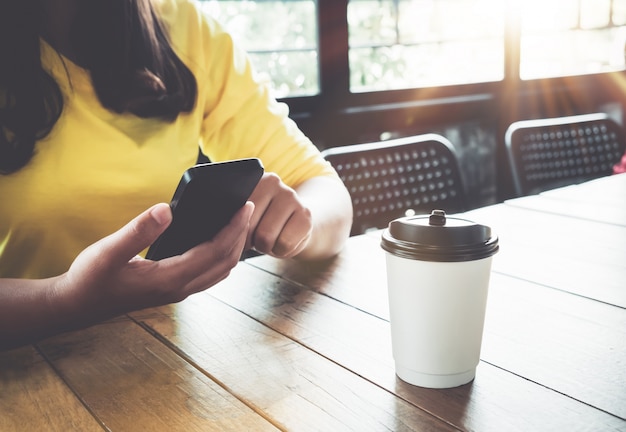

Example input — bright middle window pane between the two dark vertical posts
[348,0,506,92]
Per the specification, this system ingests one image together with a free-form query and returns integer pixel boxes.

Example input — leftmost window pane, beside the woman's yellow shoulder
[199,0,319,97]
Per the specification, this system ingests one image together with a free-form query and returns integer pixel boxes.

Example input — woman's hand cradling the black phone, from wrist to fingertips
[55,202,254,319]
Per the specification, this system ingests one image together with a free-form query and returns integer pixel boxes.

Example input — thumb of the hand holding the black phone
[100,203,172,266]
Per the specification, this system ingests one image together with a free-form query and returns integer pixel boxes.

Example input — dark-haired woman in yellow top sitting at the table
[0,0,352,348]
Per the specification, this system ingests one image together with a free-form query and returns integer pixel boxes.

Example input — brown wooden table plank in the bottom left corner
[0,346,102,432]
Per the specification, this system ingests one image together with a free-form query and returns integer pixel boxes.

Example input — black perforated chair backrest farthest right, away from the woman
[505,113,626,196]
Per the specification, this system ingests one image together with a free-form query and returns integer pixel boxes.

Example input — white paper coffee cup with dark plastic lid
[381,212,498,388]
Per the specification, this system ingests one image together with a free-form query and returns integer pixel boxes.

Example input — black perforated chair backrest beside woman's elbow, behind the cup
[322,134,465,235]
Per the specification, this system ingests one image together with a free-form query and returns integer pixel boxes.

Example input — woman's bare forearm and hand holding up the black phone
[0,202,254,349]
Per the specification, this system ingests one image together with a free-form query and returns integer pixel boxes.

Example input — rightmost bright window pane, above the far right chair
[517,0,626,79]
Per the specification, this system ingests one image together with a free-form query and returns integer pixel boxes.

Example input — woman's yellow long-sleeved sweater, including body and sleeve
[0,0,336,278]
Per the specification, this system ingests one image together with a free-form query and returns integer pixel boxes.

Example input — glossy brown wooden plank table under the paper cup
[0,175,626,432]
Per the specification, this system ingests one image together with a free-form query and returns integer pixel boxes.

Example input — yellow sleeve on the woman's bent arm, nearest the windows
[173,2,337,187]
